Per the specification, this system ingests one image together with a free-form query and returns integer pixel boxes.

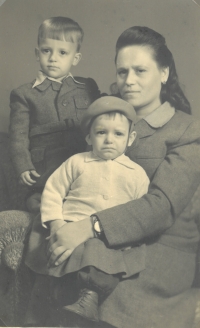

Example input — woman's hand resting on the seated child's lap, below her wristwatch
[47,217,94,267]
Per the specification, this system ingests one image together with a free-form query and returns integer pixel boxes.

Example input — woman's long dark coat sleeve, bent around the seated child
[96,121,200,246]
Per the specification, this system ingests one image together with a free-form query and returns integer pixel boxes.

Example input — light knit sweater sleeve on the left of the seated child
[40,158,73,227]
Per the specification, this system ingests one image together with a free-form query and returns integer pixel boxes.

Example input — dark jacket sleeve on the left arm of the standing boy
[9,89,35,176]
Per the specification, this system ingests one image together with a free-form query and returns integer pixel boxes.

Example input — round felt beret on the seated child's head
[81,96,136,135]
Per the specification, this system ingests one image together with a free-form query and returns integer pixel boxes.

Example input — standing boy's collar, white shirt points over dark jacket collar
[32,71,84,91]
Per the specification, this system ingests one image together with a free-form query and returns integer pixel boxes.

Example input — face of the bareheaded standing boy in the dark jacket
[35,39,81,79]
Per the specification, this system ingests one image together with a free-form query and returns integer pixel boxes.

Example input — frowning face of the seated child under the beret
[86,113,136,160]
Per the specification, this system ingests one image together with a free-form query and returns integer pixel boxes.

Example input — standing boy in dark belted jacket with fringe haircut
[10,17,100,211]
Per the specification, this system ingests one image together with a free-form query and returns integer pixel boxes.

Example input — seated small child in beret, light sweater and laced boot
[26,96,149,321]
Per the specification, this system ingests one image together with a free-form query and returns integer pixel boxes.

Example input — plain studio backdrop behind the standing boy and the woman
[0,0,200,132]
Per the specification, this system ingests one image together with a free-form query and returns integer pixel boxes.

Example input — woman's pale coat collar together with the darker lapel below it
[135,101,175,138]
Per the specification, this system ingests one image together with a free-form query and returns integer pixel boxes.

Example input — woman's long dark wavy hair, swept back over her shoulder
[115,26,191,114]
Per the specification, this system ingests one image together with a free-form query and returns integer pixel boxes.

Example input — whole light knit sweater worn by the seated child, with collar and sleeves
[41,152,149,226]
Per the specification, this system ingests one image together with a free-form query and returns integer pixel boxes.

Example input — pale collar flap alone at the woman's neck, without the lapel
[143,101,175,128]
